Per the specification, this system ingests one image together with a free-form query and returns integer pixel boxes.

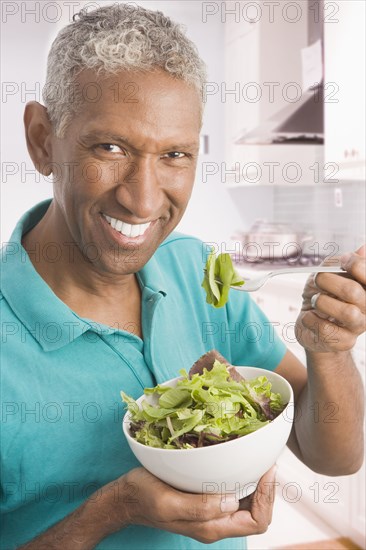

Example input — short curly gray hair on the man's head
[43,4,206,137]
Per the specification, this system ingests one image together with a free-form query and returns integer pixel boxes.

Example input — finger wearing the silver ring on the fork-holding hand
[311,293,365,334]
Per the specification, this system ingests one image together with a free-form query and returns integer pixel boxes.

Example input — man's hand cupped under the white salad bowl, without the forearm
[98,468,275,543]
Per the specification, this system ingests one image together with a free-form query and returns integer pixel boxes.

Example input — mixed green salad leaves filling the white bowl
[121,361,285,449]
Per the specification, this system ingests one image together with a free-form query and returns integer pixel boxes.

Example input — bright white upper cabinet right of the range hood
[324,0,366,181]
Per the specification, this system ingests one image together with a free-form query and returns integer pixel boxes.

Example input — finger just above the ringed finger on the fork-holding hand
[316,273,366,313]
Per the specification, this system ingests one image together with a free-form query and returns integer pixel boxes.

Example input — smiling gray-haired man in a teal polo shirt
[1,5,366,550]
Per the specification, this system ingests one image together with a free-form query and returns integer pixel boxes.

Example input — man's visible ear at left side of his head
[24,101,52,176]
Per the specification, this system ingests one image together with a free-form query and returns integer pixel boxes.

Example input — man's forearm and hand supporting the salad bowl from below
[20,465,275,550]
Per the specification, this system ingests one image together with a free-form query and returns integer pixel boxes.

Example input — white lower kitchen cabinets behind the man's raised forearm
[249,278,366,548]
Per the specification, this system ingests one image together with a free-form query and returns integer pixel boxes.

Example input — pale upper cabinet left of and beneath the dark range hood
[221,2,324,187]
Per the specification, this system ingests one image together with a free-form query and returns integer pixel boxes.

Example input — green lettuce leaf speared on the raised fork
[201,248,244,308]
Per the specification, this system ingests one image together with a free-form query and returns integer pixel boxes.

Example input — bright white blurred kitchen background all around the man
[1,0,366,550]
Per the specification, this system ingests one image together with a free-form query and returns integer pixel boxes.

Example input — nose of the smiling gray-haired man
[115,158,165,220]
